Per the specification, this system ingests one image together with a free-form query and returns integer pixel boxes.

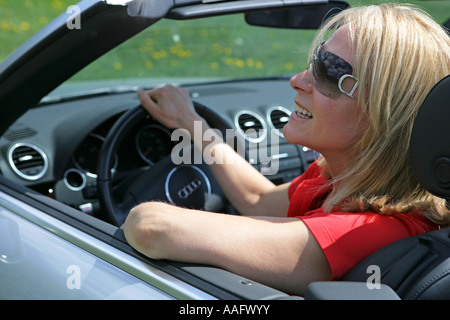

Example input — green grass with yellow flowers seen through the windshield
[72,15,315,80]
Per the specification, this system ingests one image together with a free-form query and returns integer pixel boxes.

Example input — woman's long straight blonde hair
[311,4,450,225]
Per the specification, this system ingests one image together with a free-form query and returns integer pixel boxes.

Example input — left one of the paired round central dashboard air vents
[234,110,267,142]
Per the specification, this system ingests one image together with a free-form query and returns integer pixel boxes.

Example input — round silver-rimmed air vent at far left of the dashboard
[8,143,48,180]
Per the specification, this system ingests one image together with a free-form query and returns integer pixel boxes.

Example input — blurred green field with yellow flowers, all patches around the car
[0,0,450,80]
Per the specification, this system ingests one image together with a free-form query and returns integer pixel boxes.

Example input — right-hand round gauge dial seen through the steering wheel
[136,124,174,164]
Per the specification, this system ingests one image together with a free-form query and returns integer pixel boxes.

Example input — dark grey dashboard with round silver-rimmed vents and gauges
[0,78,317,216]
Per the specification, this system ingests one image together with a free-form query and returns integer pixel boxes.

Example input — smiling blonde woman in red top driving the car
[123,4,450,295]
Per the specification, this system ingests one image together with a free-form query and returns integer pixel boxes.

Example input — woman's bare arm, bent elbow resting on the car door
[122,202,331,294]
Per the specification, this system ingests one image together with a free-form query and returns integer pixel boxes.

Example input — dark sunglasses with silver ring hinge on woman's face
[311,41,358,99]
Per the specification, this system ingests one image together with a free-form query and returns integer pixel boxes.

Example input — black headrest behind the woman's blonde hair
[409,75,450,199]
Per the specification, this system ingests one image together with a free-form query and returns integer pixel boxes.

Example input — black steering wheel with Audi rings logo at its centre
[97,102,231,226]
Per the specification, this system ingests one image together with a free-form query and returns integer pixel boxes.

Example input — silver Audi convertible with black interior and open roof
[0,0,450,300]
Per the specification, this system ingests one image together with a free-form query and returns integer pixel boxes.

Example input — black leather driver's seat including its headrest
[305,75,450,300]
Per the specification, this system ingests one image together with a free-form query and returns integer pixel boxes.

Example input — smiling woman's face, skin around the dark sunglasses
[283,27,366,160]
